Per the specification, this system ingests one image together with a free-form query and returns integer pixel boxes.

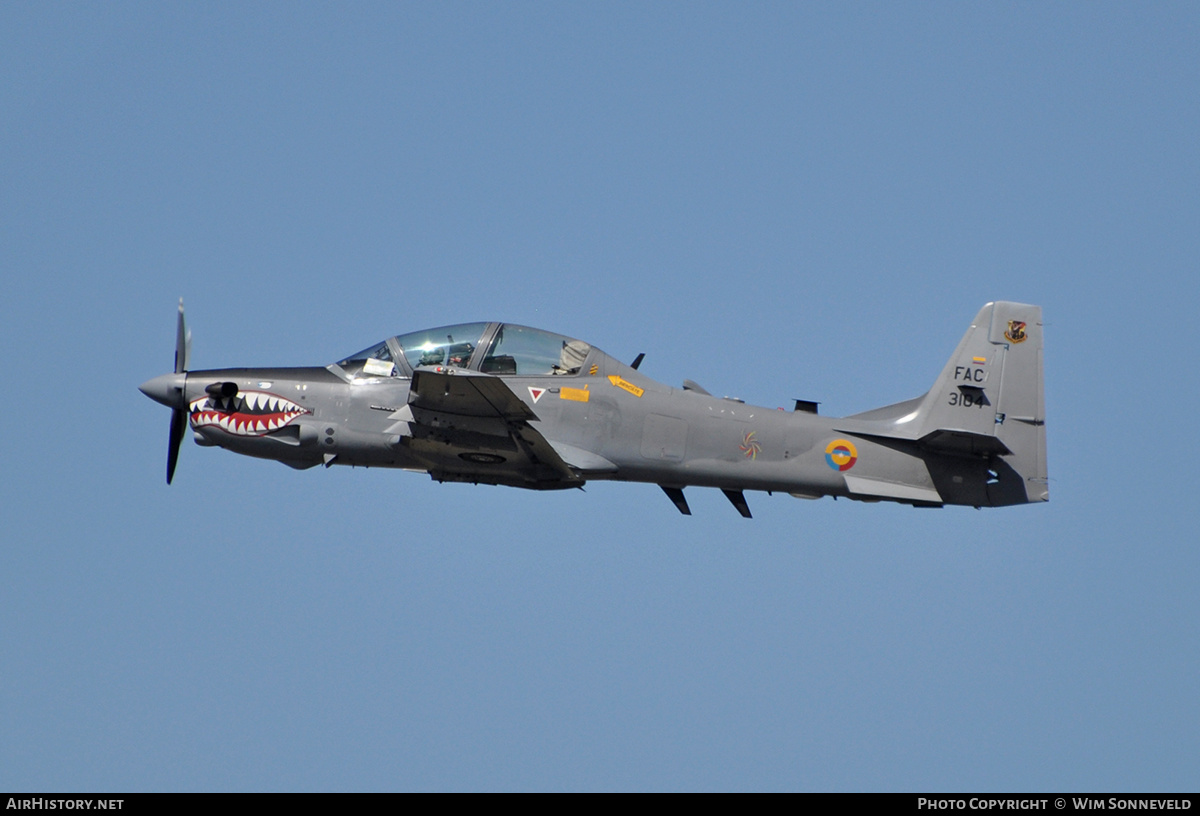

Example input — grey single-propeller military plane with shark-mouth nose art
[142,301,1049,517]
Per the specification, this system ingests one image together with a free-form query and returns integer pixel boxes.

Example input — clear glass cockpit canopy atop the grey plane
[337,323,592,378]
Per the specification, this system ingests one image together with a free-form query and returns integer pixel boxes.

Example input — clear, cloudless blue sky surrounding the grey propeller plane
[0,2,1200,791]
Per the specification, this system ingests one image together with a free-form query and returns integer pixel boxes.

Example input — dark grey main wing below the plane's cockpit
[398,368,584,490]
